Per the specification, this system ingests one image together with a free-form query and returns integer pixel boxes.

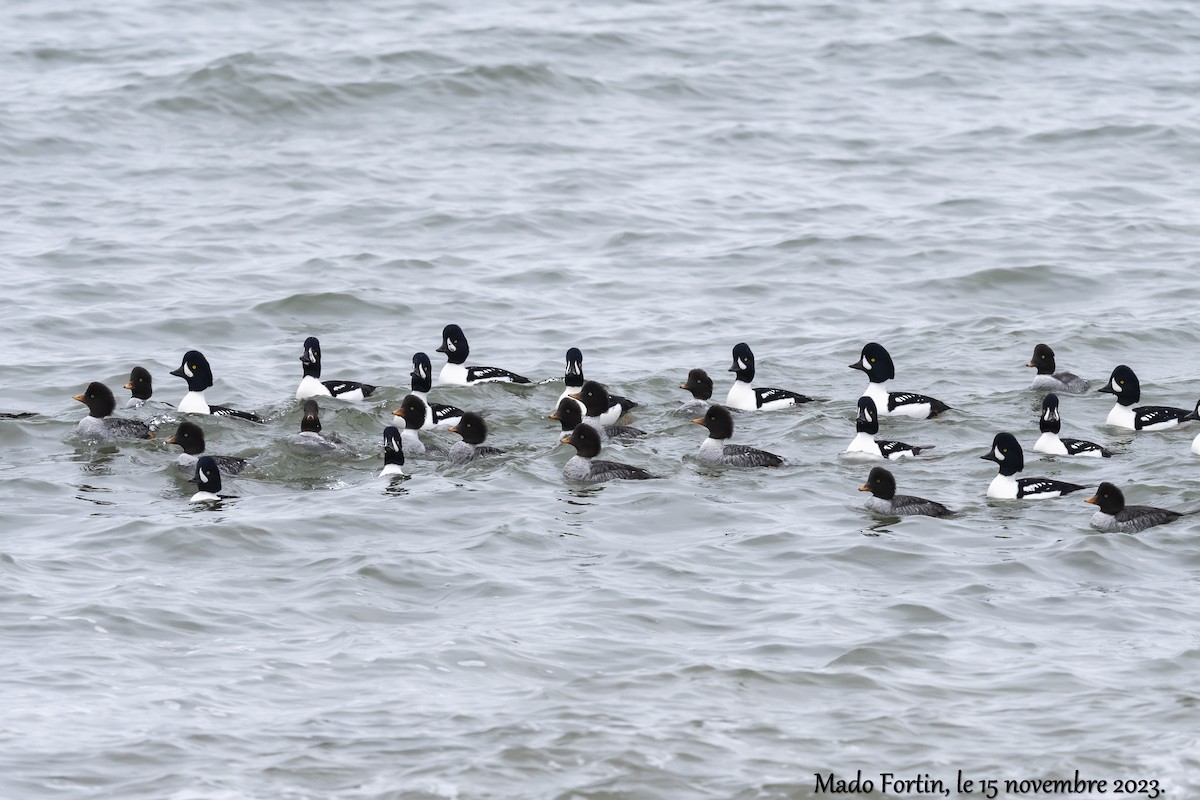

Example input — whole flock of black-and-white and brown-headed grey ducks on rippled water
[74,325,1200,533]
